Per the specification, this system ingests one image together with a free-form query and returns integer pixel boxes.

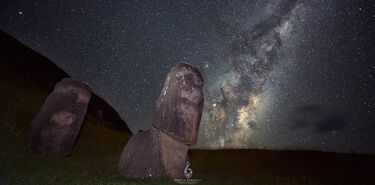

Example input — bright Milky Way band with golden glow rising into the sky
[202,1,297,147]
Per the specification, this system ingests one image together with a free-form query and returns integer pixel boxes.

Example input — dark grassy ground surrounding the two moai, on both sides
[0,72,375,185]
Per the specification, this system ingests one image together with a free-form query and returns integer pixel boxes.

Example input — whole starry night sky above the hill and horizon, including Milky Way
[0,0,375,153]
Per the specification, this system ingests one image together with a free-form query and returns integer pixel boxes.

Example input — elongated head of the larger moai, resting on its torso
[152,63,203,145]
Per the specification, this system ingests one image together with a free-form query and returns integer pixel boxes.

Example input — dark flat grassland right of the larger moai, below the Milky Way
[190,149,375,185]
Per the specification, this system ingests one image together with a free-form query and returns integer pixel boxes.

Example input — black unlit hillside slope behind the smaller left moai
[0,31,130,132]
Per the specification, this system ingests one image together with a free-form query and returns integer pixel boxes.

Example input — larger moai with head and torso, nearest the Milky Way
[119,63,203,179]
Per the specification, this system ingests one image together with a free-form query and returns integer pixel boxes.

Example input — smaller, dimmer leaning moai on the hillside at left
[24,78,91,156]
